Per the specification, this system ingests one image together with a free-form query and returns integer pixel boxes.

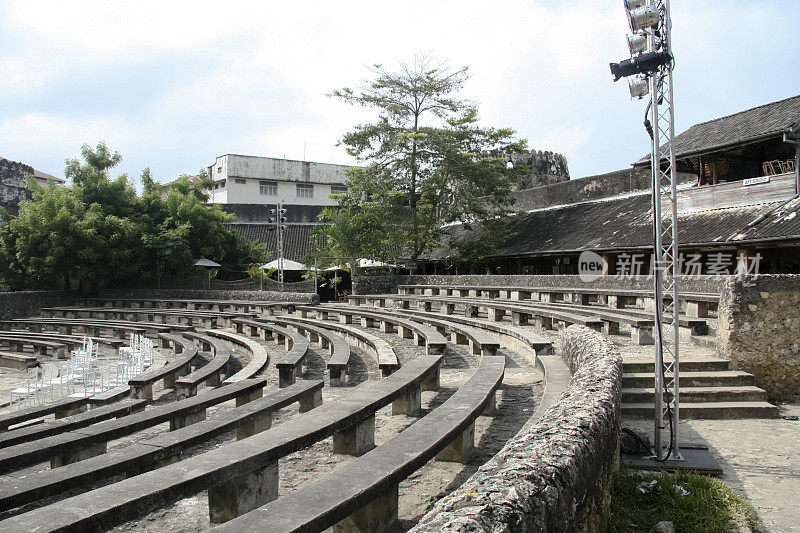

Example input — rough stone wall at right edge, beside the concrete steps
[717,274,800,399]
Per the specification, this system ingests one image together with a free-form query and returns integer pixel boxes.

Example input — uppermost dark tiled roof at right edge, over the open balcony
[637,95,800,163]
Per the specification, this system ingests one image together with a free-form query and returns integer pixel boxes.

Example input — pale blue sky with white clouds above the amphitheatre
[0,0,800,187]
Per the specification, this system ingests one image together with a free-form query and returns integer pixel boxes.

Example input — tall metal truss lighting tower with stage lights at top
[610,0,681,461]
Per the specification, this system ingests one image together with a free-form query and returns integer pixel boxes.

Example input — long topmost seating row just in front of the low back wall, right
[397,285,719,318]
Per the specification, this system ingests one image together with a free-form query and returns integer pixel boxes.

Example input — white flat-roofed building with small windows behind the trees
[208,154,348,206]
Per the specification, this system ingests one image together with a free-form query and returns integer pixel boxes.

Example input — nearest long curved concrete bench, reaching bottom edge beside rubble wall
[209,357,505,533]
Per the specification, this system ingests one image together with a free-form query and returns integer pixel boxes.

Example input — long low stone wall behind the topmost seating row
[353,275,725,294]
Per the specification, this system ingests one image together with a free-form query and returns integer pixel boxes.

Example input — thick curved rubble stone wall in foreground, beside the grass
[412,326,622,532]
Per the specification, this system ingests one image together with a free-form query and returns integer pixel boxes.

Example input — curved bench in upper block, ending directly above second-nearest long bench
[296,305,447,354]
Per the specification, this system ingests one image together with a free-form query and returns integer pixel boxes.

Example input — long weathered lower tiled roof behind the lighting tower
[424,194,800,260]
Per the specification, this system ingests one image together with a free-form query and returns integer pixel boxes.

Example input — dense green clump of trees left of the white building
[0,143,265,288]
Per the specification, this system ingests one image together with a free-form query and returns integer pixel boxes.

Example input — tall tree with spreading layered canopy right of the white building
[332,55,527,269]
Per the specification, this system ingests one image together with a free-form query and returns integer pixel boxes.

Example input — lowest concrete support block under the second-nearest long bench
[208,462,278,524]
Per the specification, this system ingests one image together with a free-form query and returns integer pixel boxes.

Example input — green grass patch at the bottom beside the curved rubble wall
[606,467,758,533]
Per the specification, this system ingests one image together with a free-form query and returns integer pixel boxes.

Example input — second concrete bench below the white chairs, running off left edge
[0,399,147,448]
